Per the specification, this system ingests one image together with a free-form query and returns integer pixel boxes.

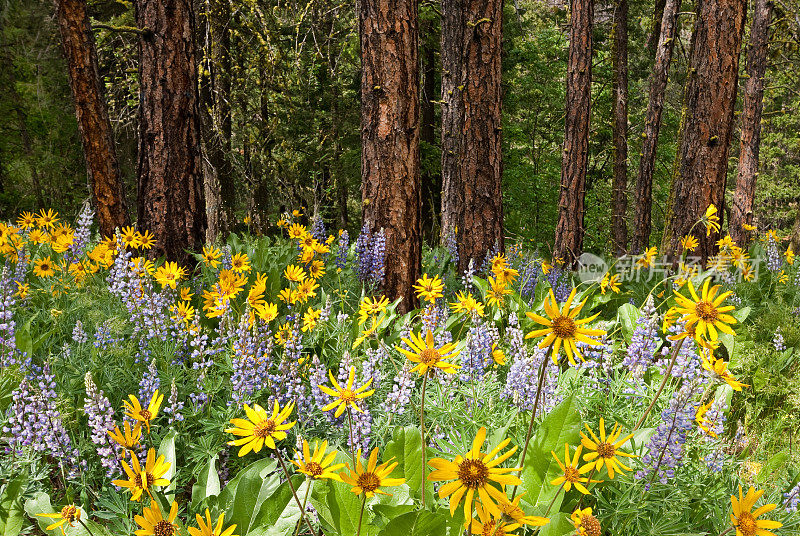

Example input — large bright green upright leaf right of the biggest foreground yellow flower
[521,394,581,515]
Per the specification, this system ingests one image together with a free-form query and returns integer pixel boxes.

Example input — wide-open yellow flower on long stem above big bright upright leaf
[525,288,606,365]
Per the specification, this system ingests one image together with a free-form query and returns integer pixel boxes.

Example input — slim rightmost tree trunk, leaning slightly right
[728,0,772,247]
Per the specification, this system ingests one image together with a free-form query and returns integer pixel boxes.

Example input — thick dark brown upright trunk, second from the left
[135,0,206,264]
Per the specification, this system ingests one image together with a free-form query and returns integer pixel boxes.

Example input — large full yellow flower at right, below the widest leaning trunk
[675,278,736,341]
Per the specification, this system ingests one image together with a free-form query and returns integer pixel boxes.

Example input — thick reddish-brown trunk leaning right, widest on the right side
[662,0,747,265]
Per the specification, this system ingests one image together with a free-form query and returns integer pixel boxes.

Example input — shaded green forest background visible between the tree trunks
[0,0,800,252]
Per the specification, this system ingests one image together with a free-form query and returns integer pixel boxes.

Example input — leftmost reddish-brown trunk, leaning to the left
[55,0,130,236]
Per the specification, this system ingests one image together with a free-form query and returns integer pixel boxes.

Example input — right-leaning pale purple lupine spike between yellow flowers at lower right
[635,382,701,489]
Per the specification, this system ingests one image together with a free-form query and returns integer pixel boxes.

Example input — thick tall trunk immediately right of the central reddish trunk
[442,0,504,272]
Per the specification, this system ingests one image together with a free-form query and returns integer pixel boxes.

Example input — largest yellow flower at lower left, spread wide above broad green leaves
[225,400,297,457]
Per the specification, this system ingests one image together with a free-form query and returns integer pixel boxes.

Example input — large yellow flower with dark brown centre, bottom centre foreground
[428,427,522,520]
